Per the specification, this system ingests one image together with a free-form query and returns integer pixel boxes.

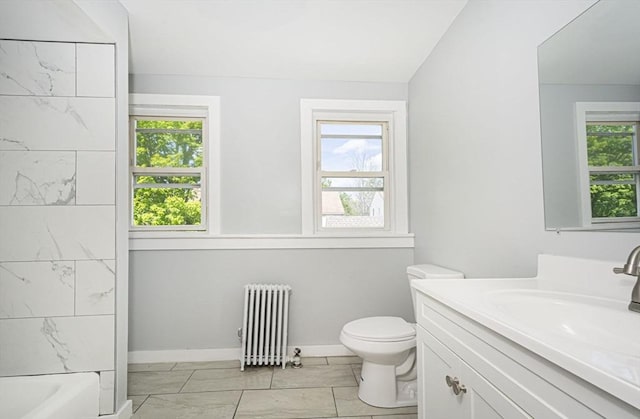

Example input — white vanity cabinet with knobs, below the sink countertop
[416,290,639,419]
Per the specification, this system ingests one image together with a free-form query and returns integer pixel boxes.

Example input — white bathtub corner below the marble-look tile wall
[0,372,100,419]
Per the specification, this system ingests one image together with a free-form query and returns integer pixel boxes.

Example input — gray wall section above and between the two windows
[130,75,407,234]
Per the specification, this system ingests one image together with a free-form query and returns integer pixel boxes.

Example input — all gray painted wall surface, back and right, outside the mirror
[130,1,640,350]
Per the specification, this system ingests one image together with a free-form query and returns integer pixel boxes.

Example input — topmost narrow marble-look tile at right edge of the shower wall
[76,44,115,97]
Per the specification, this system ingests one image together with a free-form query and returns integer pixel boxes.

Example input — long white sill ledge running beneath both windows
[129,232,414,250]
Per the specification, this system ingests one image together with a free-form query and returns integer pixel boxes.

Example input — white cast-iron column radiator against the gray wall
[240,284,291,371]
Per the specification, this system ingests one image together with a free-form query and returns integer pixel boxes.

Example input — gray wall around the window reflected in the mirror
[540,84,640,228]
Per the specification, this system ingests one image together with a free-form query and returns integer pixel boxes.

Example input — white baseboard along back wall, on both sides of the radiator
[129,345,353,364]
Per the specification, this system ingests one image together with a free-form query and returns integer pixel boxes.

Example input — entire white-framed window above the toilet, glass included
[301,99,407,234]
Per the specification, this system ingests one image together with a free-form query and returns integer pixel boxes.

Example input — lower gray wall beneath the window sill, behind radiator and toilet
[129,249,413,351]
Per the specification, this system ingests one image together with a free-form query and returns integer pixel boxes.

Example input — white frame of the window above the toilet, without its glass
[300,99,408,237]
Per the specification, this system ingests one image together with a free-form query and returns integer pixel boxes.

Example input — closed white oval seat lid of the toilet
[342,316,416,342]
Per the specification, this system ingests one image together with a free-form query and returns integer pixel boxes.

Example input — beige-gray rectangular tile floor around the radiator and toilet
[129,357,417,419]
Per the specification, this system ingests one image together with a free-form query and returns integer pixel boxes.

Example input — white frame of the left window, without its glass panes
[129,94,220,238]
